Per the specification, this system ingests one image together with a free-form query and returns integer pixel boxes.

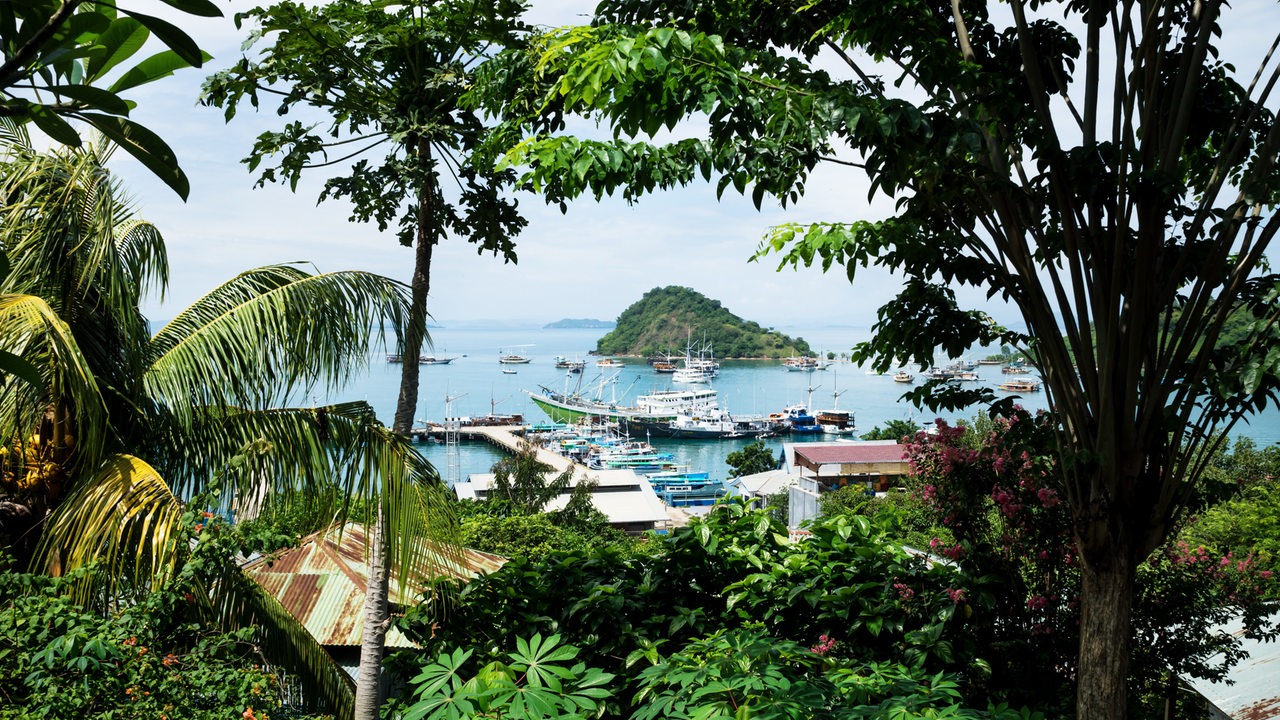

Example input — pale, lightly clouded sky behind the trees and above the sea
[111,0,1280,328]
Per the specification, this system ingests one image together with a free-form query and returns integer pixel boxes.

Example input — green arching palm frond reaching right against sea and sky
[143,265,408,423]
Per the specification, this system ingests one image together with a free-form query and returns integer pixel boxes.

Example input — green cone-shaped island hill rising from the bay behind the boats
[595,286,810,359]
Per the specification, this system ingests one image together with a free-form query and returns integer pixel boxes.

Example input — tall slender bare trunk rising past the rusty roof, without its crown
[355,140,435,720]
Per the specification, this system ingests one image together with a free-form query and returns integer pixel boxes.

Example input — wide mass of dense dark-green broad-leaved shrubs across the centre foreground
[398,503,1039,716]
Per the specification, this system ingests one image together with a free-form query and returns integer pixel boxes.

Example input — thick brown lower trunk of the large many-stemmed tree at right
[1075,536,1135,720]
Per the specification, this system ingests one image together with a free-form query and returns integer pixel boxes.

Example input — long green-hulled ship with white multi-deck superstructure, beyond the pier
[526,373,719,423]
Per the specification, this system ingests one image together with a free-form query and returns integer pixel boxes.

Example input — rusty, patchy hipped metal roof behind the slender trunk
[244,524,506,647]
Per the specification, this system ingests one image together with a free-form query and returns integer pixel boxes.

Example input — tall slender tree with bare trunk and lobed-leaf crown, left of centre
[204,0,525,720]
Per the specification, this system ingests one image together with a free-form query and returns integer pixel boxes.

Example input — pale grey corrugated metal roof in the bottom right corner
[1187,615,1280,720]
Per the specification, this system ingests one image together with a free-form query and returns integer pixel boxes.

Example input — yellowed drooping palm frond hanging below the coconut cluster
[37,455,183,606]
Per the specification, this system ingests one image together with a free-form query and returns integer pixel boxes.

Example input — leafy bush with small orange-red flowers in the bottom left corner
[0,504,317,720]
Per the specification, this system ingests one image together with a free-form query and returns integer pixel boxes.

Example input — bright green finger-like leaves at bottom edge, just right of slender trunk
[403,634,613,720]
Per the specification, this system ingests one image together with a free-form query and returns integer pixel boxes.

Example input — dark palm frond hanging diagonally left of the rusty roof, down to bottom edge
[212,569,356,720]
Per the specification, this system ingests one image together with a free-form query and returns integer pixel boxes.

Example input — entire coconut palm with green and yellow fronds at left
[0,126,456,715]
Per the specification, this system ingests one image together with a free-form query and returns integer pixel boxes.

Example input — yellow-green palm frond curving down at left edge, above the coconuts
[0,289,110,465]
